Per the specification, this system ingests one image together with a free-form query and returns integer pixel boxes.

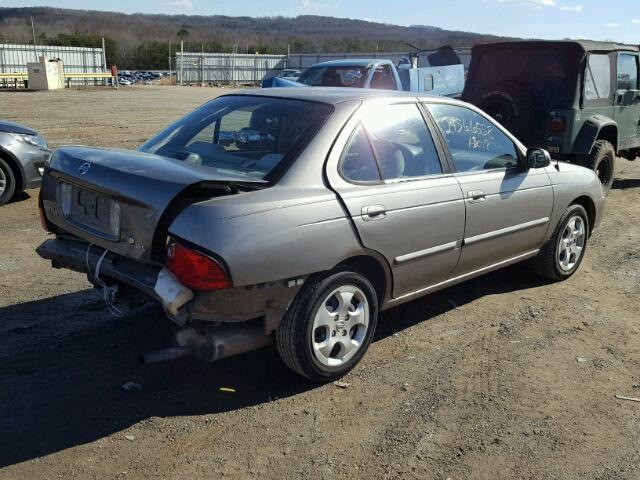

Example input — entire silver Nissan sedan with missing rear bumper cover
[38,88,604,382]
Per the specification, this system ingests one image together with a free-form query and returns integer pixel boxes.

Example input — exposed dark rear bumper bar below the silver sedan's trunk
[36,237,194,324]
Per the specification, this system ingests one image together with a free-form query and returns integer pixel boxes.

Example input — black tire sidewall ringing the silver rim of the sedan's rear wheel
[298,271,378,381]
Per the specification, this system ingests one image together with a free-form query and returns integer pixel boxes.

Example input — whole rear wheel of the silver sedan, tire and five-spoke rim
[276,269,378,383]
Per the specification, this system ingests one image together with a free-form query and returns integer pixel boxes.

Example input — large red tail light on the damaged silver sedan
[165,239,231,291]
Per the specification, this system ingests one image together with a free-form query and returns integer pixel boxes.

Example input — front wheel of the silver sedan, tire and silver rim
[531,204,590,281]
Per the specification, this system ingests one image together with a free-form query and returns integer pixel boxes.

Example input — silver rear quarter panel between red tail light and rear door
[169,186,362,286]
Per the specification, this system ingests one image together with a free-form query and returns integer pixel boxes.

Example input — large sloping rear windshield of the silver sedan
[140,95,332,182]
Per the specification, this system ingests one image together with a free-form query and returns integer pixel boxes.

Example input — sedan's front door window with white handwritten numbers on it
[427,104,518,172]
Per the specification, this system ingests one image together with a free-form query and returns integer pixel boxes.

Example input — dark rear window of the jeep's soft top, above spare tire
[469,45,582,108]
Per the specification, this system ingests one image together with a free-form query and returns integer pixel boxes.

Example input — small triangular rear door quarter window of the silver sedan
[338,125,381,183]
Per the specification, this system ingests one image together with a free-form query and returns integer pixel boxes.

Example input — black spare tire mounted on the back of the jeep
[472,82,536,140]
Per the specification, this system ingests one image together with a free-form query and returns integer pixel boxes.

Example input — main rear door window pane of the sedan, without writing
[363,104,442,180]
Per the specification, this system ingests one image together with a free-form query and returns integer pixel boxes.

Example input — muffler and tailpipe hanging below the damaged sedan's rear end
[138,322,273,364]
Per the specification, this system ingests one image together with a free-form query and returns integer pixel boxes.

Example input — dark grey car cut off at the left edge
[0,120,51,205]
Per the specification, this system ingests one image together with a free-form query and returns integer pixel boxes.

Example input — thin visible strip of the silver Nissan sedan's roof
[228,87,428,105]
